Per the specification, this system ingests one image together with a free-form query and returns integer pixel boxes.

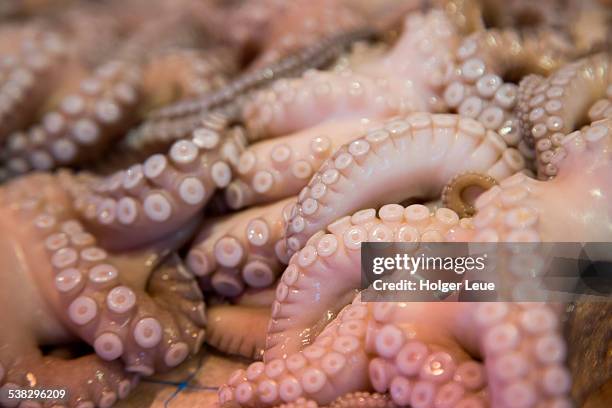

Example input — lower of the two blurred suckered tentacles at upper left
[4,61,141,175]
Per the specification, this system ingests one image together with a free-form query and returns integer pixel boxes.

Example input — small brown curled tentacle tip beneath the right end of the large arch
[442,172,498,218]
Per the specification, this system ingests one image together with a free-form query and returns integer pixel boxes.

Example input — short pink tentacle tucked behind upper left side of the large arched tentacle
[225,120,365,209]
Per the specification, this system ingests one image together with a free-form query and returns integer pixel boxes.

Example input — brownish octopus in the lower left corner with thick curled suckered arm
[0,174,206,407]
